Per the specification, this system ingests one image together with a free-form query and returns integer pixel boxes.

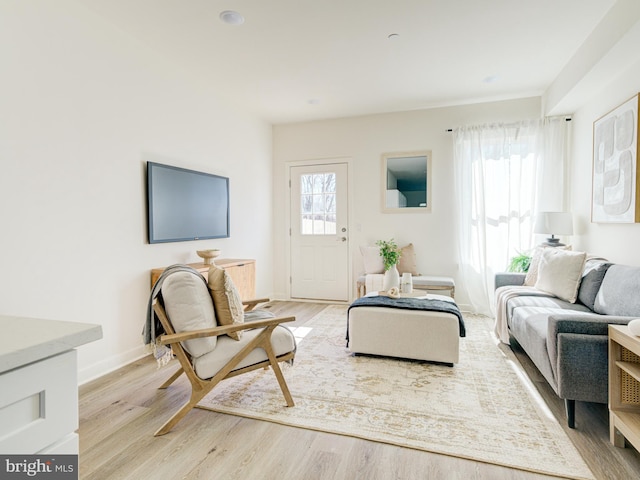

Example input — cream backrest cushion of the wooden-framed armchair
[162,272,217,357]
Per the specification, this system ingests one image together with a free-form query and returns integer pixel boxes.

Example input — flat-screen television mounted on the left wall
[147,162,229,243]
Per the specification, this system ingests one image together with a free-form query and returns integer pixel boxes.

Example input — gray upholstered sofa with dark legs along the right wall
[495,259,640,428]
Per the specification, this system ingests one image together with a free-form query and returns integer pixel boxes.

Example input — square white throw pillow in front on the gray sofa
[535,248,587,303]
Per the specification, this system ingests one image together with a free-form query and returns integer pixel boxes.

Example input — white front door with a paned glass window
[289,163,349,301]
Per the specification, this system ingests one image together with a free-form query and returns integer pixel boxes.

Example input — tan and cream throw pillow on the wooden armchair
[209,265,244,340]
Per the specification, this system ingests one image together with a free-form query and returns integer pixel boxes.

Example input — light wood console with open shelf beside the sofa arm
[609,325,640,450]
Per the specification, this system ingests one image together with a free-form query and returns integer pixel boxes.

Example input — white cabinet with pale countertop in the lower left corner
[0,316,102,455]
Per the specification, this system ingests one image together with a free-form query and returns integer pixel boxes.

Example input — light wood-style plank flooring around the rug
[80,302,640,480]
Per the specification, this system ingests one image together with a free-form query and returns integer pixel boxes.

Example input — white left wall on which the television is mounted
[0,0,273,380]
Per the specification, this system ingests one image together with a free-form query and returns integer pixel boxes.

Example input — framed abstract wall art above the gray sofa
[591,95,640,223]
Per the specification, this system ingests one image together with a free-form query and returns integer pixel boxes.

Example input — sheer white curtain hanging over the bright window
[453,119,567,315]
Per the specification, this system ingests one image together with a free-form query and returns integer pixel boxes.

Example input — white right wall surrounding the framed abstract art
[569,61,640,266]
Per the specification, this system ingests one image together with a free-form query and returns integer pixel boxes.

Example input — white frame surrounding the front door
[284,157,354,303]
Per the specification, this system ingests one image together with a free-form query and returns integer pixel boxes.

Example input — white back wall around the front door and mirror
[273,98,541,304]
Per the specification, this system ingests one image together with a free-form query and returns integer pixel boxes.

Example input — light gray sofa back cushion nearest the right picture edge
[593,264,640,317]
